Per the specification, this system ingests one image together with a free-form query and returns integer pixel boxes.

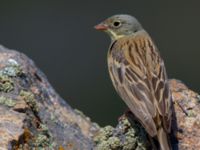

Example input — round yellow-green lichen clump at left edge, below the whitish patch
[0,75,14,93]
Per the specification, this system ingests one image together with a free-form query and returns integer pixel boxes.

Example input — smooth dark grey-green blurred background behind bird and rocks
[0,0,200,126]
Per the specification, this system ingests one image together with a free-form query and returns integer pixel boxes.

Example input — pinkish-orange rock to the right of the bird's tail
[169,80,200,150]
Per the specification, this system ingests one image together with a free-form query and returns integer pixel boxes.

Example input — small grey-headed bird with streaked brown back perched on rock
[95,15,172,150]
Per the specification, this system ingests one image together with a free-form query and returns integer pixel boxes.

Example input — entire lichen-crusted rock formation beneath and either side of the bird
[0,46,200,150]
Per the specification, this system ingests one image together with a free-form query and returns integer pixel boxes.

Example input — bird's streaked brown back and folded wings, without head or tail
[108,32,169,136]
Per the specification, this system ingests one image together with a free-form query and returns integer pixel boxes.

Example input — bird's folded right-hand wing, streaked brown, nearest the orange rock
[137,34,172,132]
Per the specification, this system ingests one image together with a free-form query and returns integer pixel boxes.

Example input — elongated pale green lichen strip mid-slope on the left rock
[19,90,39,112]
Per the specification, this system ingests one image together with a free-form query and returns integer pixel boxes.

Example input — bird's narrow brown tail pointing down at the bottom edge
[157,128,172,150]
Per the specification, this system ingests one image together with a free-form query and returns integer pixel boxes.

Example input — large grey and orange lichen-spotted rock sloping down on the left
[0,46,98,150]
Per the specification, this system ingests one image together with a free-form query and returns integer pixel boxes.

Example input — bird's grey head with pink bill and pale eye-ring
[95,14,143,40]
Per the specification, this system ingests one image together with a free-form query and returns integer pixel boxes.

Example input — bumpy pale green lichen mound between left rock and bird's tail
[93,117,147,150]
